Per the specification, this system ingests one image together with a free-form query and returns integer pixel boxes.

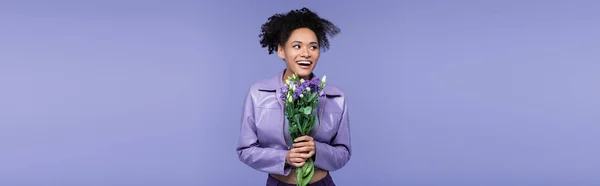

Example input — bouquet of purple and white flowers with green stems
[281,74,326,186]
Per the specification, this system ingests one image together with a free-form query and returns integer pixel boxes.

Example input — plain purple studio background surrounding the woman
[0,0,600,186]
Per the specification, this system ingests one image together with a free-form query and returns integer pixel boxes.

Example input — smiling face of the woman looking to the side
[277,28,321,79]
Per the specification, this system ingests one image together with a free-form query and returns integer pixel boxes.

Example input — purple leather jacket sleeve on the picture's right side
[314,97,352,171]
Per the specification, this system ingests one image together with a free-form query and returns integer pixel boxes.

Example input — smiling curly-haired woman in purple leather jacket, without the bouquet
[237,8,351,186]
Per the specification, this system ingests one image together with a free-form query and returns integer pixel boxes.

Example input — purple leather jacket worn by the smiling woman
[236,70,351,175]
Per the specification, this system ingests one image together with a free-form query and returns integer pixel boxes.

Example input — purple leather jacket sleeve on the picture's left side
[236,92,291,175]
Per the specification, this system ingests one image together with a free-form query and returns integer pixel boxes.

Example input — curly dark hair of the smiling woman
[258,7,340,54]
